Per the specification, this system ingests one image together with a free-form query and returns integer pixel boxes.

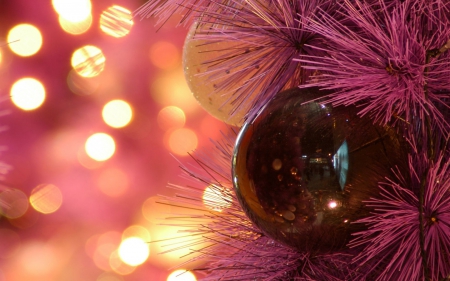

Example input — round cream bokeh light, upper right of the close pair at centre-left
[102,100,133,128]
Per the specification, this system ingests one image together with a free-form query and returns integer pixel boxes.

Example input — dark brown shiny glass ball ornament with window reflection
[233,88,407,249]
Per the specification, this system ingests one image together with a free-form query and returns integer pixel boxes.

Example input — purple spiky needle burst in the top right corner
[299,0,450,132]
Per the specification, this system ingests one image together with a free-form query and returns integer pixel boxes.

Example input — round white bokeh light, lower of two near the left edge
[10,78,45,110]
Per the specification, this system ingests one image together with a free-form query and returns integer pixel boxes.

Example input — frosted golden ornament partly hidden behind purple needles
[183,24,259,125]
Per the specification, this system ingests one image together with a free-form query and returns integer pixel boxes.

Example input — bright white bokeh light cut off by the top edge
[52,0,92,22]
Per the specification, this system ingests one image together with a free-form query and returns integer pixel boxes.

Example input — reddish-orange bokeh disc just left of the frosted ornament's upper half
[149,41,181,70]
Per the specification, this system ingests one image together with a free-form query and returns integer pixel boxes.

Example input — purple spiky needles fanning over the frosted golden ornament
[189,0,336,119]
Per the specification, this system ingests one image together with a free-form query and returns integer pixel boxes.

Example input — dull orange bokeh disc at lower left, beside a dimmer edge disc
[30,184,63,214]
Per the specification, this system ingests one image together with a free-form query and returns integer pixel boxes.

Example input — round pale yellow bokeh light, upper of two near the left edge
[6,23,42,57]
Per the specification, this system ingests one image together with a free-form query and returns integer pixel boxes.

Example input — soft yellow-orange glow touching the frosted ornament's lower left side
[150,67,201,113]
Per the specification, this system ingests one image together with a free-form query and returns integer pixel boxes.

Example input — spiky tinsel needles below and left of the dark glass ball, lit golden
[156,132,361,281]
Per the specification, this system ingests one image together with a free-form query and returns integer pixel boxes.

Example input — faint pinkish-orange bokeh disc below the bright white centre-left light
[97,168,129,197]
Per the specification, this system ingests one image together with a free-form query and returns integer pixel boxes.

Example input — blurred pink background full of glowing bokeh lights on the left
[0,0,226,281]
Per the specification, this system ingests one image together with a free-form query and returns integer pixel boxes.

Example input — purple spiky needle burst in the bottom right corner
[350,154,450,280]
